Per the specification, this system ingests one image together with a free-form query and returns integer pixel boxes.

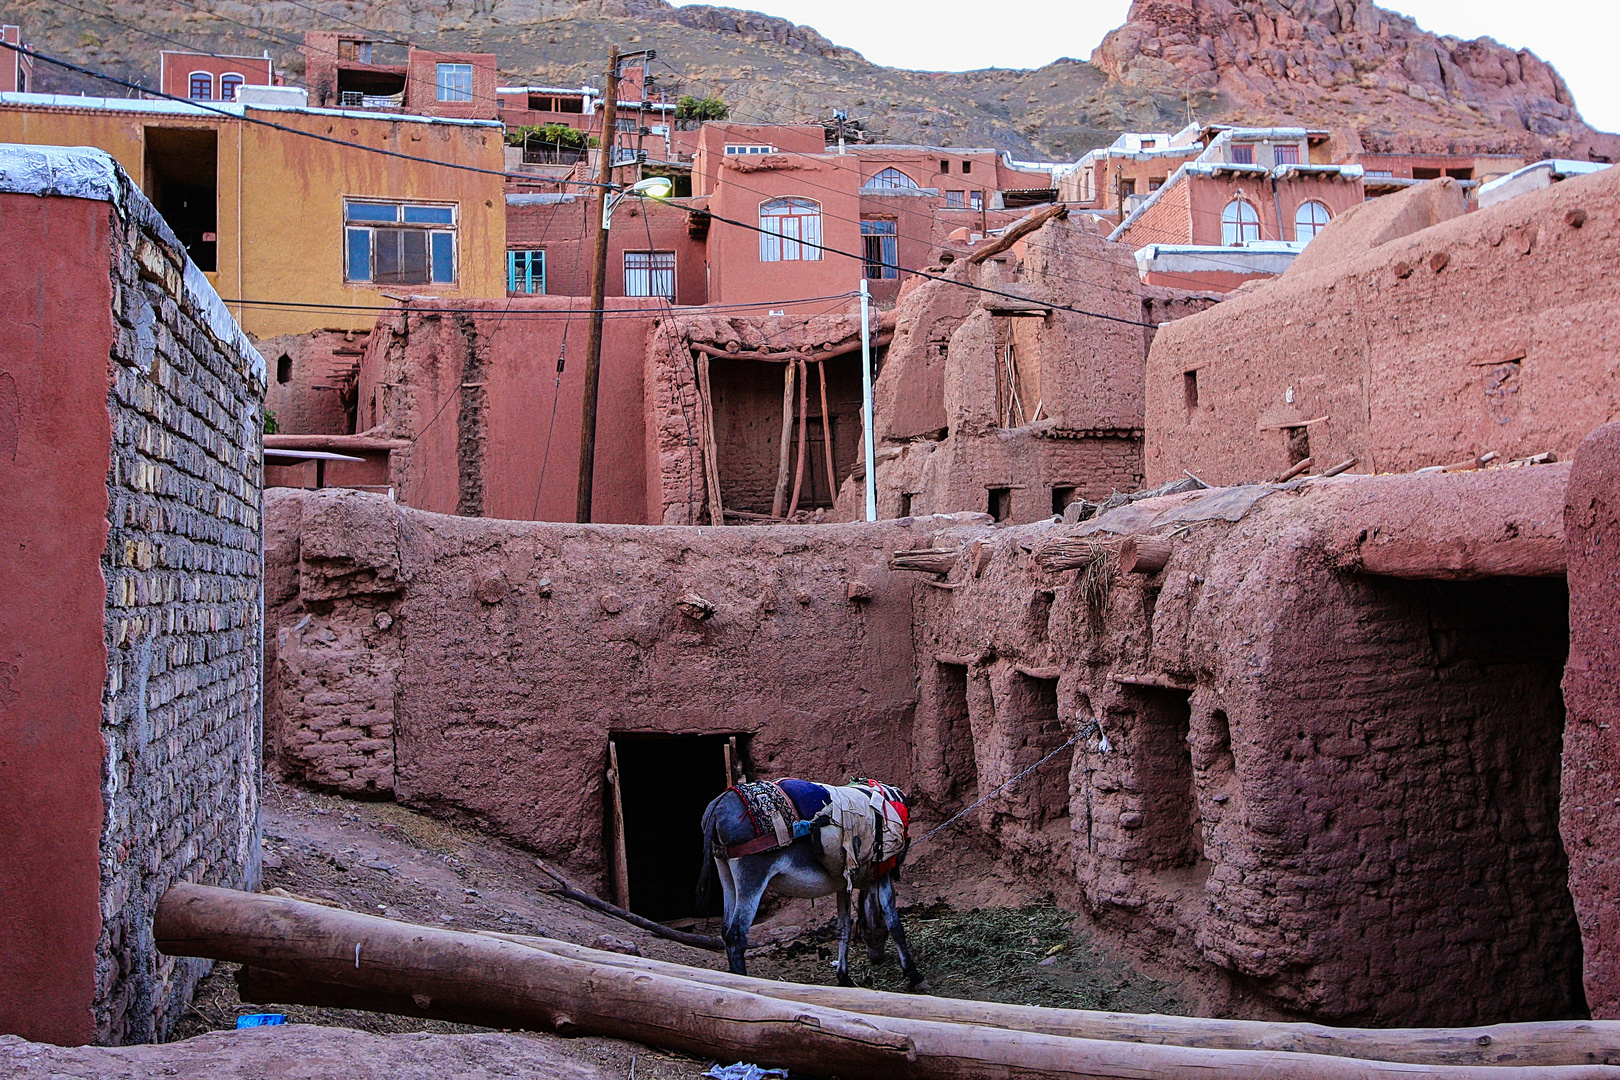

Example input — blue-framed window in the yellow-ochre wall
[343,199,455,285]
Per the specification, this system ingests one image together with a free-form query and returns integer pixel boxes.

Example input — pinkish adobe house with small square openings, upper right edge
[1145,168,1620,486]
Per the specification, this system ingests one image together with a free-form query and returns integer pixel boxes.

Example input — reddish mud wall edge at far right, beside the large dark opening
[1563,424,1620,1020]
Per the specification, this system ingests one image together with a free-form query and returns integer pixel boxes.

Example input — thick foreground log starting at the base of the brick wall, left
[152,884,915,1077]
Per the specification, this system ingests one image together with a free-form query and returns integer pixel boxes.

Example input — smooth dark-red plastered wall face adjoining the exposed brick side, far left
[0,194,113,1044]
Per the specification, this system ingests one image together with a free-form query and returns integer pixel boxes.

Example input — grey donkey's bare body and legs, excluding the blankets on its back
[698,780,932,993]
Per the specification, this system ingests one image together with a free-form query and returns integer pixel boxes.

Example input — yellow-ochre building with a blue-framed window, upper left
[0,94,505,338]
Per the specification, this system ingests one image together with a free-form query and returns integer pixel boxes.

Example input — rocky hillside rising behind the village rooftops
[0,0,1620,160]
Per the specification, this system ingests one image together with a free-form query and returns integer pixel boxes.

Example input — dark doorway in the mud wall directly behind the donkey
[609,735,731,921]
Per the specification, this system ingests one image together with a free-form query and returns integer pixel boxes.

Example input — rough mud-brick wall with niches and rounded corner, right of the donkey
[914,465,1597,1025]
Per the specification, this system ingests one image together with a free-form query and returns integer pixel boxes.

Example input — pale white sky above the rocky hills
[676,0,1620,131]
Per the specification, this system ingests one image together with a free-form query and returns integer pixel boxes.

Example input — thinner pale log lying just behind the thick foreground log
[481,932,1620,1080]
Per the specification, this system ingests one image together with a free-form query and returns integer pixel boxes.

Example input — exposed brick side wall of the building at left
[96,183,264,1043]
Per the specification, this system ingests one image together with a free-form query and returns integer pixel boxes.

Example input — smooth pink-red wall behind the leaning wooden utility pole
[360,296,666,525]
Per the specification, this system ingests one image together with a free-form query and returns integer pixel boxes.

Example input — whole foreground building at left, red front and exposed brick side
[0,144,266,1044]
